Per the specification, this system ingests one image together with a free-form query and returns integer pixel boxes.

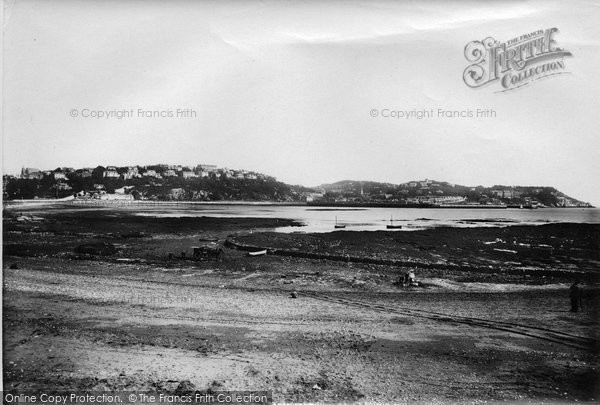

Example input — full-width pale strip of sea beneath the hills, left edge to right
[3,200,600,233]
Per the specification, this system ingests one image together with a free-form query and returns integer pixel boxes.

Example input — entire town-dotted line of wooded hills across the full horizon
[3,164,591,208]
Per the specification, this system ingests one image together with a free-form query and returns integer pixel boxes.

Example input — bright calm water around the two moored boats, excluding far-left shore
[135,204,600,232]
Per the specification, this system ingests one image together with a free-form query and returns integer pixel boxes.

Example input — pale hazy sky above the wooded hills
[2,0,600,205]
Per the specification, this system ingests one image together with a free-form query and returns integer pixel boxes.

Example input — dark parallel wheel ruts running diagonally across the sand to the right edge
[303,291,598,351]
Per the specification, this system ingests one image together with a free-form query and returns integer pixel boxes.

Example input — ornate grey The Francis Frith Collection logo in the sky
[463,28,572,92]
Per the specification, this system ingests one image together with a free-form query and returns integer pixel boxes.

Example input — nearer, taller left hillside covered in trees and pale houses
[3,165,303,202]
